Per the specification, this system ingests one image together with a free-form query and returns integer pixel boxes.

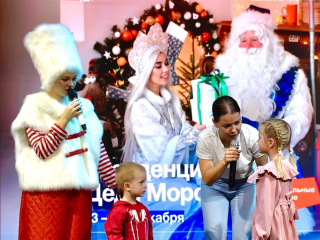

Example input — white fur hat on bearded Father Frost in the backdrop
[230,10,277,38]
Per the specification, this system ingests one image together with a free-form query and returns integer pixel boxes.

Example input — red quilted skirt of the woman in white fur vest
[19,190,92,240]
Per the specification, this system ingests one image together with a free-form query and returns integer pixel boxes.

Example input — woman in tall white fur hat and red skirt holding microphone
[11,24,116,240]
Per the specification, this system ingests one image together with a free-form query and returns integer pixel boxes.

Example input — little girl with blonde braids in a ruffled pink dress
[248,119,299,240]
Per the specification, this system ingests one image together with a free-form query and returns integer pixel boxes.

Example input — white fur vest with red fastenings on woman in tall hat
[11,92,103,191]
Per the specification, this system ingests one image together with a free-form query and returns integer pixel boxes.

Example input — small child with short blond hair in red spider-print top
[104,162,153,240]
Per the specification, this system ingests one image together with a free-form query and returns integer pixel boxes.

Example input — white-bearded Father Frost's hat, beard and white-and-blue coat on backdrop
[215,9,314,232]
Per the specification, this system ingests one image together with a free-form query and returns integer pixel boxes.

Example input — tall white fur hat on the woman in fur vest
[24,23,82,91]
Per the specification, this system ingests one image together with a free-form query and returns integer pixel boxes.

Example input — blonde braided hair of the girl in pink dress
[261,119,297,178]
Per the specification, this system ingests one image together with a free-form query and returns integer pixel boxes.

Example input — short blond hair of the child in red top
[116,162,147,200]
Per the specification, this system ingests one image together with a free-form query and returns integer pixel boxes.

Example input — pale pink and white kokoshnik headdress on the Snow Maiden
[128,23,168,75]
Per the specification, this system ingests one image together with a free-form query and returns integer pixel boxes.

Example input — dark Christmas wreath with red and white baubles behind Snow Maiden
[94,0,220,89]
